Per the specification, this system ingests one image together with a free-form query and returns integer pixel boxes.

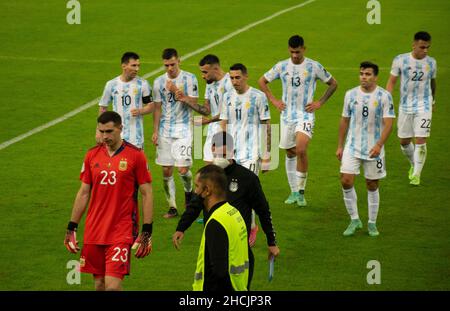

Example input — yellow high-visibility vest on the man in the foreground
[192,203,249,291]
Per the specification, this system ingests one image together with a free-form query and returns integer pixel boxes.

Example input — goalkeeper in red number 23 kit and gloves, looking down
[64,111,153,290]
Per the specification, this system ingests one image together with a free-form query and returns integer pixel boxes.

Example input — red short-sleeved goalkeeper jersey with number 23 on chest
[80,141,152,245]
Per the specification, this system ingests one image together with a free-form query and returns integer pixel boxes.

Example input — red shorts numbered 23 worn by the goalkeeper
[80,243,131,280]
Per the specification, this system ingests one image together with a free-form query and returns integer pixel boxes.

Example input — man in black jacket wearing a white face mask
[172,132,280,289]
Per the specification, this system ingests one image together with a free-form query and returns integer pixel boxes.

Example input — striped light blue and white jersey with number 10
[99,76,152,148]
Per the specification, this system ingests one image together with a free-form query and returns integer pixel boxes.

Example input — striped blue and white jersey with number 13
[264,57,332,124]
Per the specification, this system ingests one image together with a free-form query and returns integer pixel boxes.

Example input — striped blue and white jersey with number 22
[391,53,437,113]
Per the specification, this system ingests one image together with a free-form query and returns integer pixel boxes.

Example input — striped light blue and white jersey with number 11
[220,87,270,164]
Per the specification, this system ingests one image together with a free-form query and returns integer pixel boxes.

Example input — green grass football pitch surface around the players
[0,0,450,290]
